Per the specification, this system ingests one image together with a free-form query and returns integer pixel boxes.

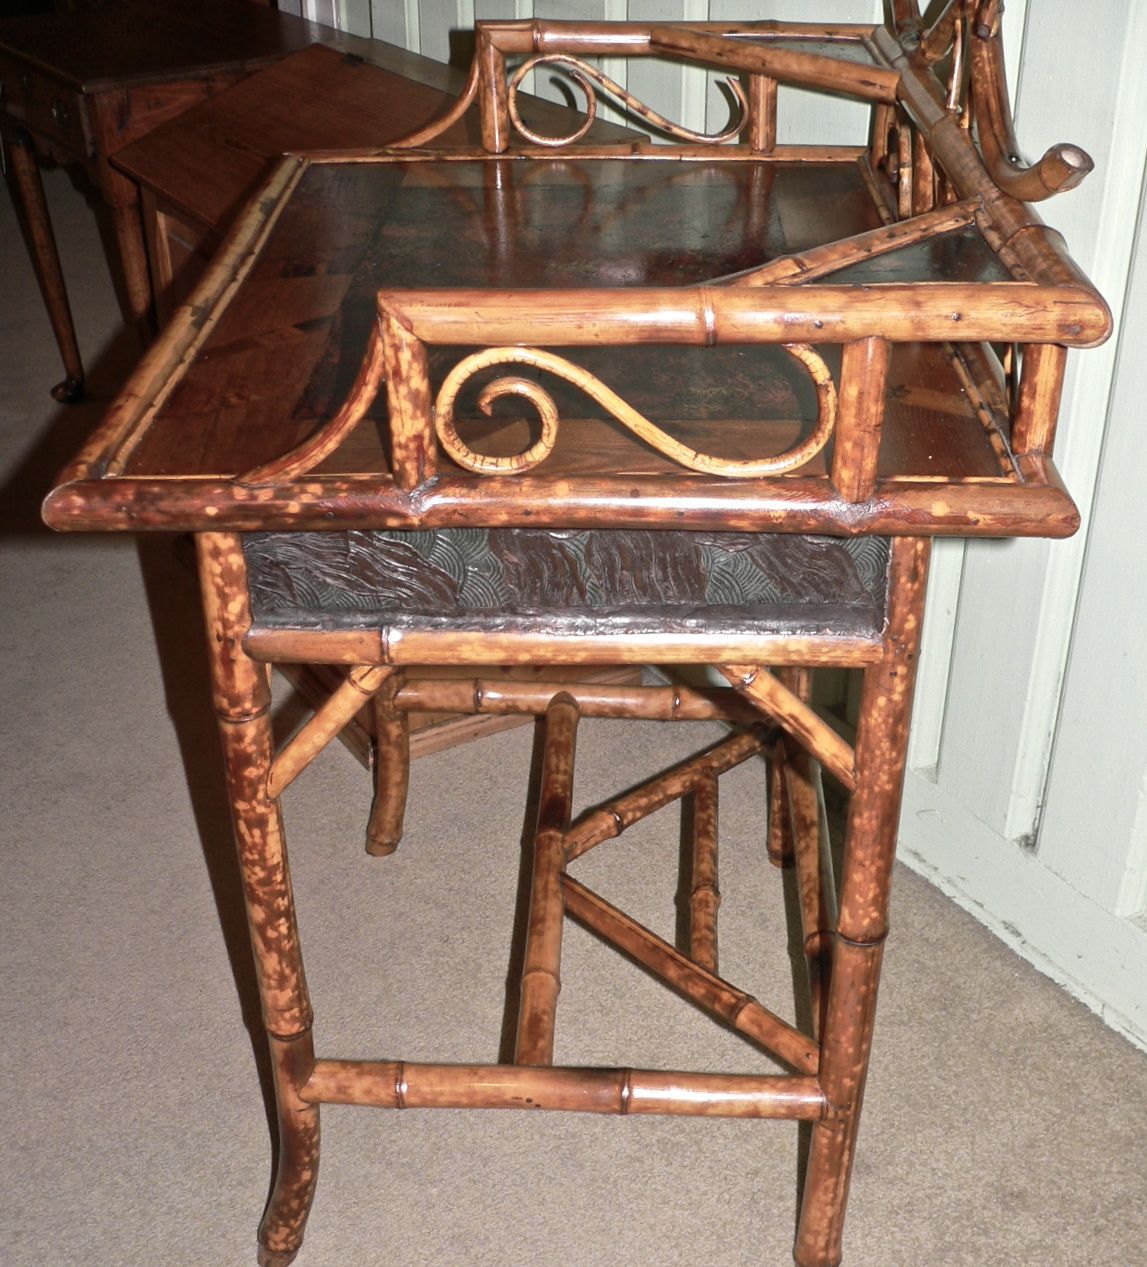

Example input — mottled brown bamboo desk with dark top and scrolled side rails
[46,0,1110,1267]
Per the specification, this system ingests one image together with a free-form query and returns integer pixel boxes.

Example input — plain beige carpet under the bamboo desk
[0,175,1147,1267]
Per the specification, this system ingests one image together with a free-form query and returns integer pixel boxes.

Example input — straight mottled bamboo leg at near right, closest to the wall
[793,538,929,1267]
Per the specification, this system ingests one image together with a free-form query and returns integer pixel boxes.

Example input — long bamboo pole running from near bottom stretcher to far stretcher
[513,694,579,1064]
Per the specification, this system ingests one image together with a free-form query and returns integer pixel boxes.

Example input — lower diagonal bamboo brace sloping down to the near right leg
[561,875,820,1073]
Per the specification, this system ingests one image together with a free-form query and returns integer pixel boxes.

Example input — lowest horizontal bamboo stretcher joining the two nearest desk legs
[303,1060,824,1121]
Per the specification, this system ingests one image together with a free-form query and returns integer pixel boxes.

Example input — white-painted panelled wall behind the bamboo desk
[288,0,1147,1047]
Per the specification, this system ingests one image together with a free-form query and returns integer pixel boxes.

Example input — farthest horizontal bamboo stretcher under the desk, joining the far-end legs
[394,678,760,722]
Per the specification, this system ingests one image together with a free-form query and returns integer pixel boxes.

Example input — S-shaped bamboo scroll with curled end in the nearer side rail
[435,343,836,479]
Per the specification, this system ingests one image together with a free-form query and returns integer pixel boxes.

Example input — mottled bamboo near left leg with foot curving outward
[196,533,318,1267]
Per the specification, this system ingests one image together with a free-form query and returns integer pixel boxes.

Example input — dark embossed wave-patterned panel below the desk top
[245,528,888,635]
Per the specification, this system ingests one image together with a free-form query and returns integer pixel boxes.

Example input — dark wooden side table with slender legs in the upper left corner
[0,0,354,400]
